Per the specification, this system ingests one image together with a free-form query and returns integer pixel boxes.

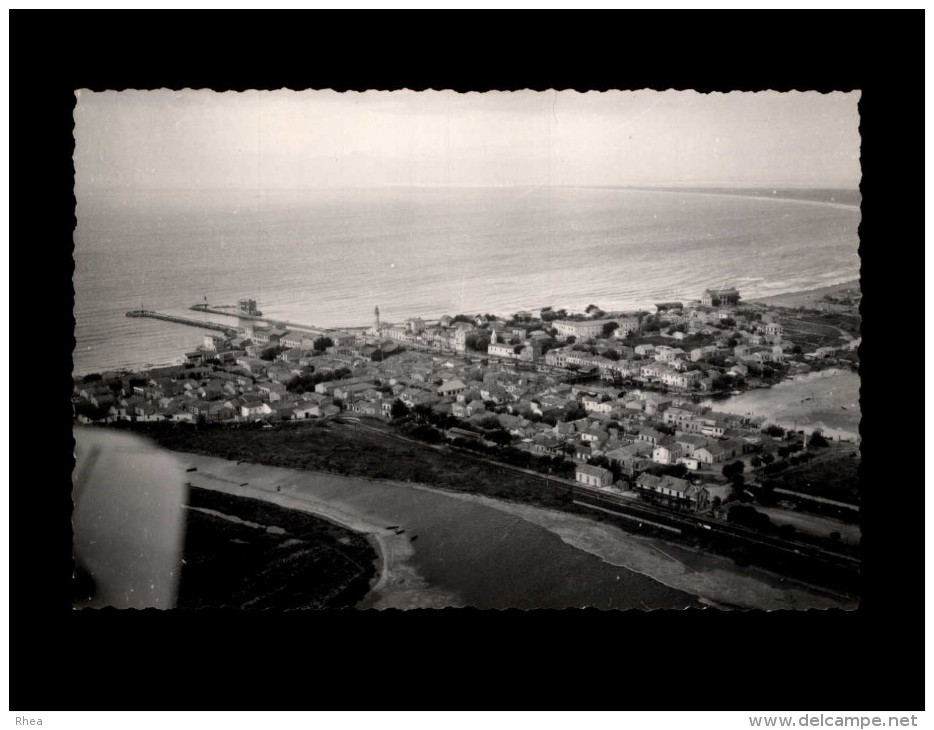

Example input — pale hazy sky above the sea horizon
[74,90,860,192]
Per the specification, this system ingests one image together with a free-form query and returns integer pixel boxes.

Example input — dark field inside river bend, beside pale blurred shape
[177,488,377,610]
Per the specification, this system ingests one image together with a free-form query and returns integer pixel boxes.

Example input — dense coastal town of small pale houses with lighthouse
[74,288,860,564]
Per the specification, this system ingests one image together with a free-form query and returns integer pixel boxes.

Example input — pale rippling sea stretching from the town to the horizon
[74,187,860,374]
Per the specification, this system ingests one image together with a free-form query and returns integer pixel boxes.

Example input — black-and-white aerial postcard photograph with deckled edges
[72,89,861,611]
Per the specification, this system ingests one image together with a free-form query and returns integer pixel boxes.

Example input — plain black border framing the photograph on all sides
[10,11,924,711]
